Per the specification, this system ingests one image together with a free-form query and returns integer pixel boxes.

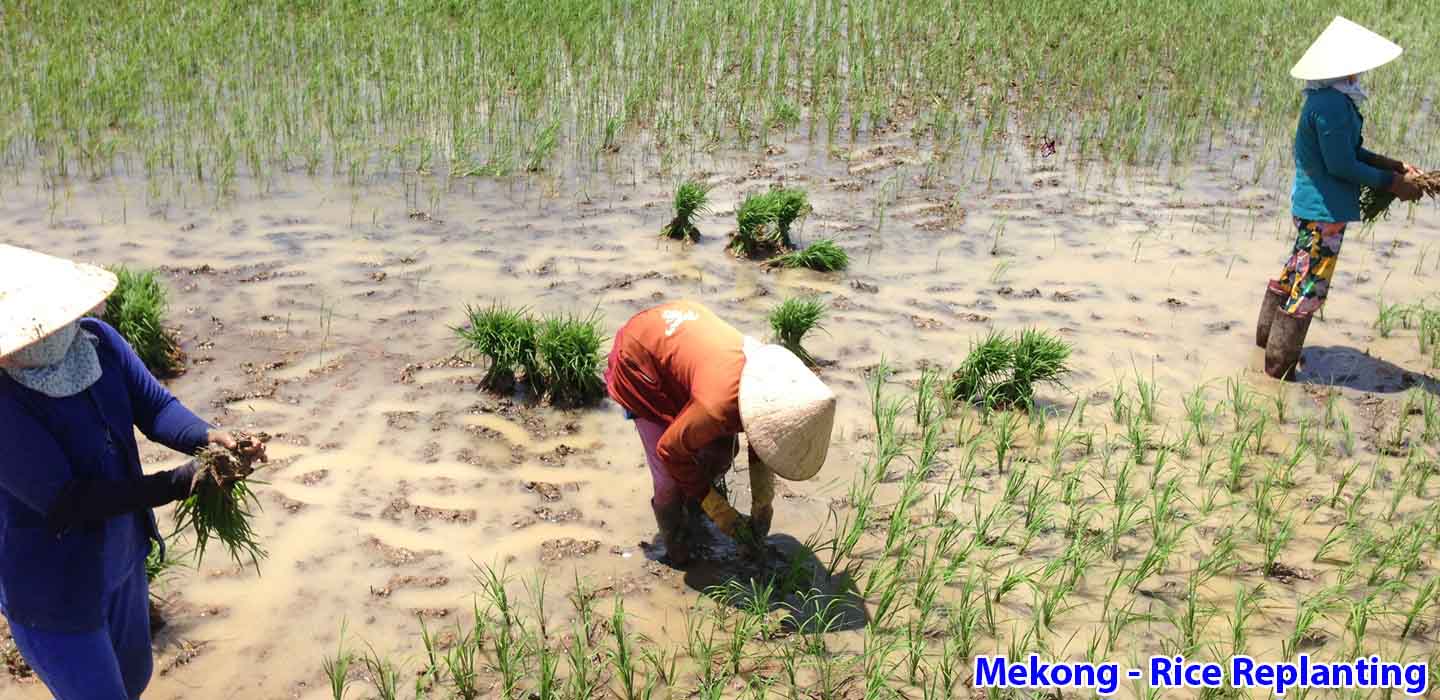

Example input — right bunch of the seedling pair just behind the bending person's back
[530,314,605,406]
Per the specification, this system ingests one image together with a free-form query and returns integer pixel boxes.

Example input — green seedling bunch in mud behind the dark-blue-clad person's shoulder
[102,265,184,377]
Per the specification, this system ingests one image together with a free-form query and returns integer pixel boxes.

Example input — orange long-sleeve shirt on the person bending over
[605,301,744,498]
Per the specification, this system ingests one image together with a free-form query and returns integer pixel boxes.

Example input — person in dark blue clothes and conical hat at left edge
[0,245,264,700]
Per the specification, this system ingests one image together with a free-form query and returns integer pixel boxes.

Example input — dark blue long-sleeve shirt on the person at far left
[0,318,210,631]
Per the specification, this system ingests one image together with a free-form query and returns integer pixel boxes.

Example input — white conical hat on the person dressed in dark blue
[0,243,115,357]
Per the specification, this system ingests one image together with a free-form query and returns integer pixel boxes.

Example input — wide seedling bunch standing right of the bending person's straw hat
[949,330,1073,409]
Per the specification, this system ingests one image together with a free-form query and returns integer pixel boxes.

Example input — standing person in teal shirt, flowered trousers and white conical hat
[1256,17,1420,379]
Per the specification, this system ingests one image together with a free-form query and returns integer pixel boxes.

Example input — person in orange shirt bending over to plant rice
[605,301,835,566]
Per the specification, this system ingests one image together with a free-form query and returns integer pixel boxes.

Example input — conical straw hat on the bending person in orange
[740,338,835,481]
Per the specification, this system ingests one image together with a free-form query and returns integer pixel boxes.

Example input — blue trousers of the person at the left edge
[10,566,154,700]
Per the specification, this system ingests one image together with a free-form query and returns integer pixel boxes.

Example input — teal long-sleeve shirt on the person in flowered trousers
[1290,88,1395,222]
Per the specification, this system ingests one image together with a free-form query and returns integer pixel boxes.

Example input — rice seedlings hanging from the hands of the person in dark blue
[174,432,269,572]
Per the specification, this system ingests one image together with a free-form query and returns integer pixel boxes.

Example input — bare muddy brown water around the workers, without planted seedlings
[0,129,1440,699]
